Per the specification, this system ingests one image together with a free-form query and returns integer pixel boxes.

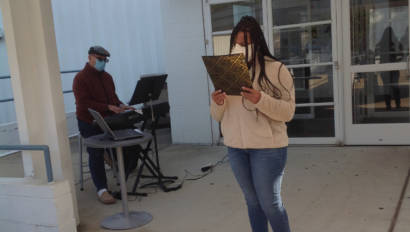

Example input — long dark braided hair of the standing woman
[229,16,289,99]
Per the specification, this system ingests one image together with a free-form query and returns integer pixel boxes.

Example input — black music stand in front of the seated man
[129,74,181,192]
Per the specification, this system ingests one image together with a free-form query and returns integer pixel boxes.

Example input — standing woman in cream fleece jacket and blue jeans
[211,16,295,232]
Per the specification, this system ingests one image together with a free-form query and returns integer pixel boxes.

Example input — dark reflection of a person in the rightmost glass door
[376,27,403,110]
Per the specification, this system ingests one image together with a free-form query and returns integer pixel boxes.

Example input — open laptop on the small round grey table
[88,109,144,141]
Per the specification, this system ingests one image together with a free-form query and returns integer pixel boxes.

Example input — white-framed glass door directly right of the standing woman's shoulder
[268,0,342,144]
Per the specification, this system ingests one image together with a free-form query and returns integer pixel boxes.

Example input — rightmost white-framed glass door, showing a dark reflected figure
[343,0,410,144]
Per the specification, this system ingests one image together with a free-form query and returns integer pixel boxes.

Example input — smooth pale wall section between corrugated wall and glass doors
[161,0,212,144]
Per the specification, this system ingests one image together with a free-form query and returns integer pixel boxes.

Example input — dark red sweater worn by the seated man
[73,63,123,123]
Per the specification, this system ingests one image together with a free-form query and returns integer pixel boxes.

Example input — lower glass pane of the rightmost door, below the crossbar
[352,70,410,124]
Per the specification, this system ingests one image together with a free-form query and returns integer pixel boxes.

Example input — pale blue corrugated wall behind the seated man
[0,0,164,124]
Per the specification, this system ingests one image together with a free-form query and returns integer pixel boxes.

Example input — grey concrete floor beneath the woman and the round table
[0,130,410,232]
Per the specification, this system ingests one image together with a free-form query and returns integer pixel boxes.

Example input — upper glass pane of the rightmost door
[350,0,409,64]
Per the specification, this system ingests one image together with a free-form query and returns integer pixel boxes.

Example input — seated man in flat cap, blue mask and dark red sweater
[73,46,133,204]
